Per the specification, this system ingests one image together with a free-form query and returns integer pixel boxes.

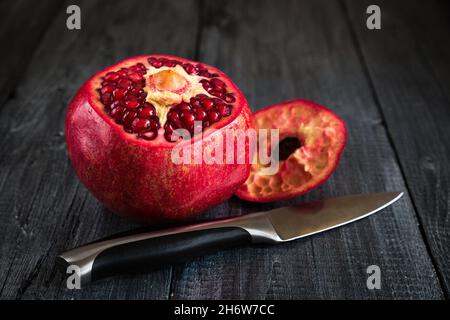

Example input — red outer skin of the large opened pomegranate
[65,56,253,223]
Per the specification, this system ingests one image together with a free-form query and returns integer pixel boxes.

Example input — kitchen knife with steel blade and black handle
[58,192,403,284]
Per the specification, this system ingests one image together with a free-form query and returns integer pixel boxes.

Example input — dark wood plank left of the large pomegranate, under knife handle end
[0,0,198,299]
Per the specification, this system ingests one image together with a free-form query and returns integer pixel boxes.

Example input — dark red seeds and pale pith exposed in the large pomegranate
[94,57,236,142]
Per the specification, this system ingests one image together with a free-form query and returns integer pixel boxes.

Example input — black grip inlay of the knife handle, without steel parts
[90,227,252,281]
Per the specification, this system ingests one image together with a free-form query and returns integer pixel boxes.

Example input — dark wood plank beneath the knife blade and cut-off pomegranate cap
[171,0,443,299]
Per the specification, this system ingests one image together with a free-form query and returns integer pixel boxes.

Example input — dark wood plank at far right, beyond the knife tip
[347,1,450,297]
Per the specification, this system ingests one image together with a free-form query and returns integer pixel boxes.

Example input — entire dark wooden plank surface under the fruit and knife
[0,0,450,299]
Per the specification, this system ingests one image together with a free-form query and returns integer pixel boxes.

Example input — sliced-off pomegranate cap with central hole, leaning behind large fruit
[236,100,347,202]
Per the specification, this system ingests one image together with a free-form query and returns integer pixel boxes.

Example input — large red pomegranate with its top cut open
[66,55,253,222]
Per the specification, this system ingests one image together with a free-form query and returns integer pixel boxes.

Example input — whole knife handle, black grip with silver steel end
[59,227,252,284]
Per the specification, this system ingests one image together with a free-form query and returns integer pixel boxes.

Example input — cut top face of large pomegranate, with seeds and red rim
[86,55,247,146]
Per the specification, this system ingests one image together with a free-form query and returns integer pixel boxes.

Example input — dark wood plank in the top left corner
[0,0,62,106]
